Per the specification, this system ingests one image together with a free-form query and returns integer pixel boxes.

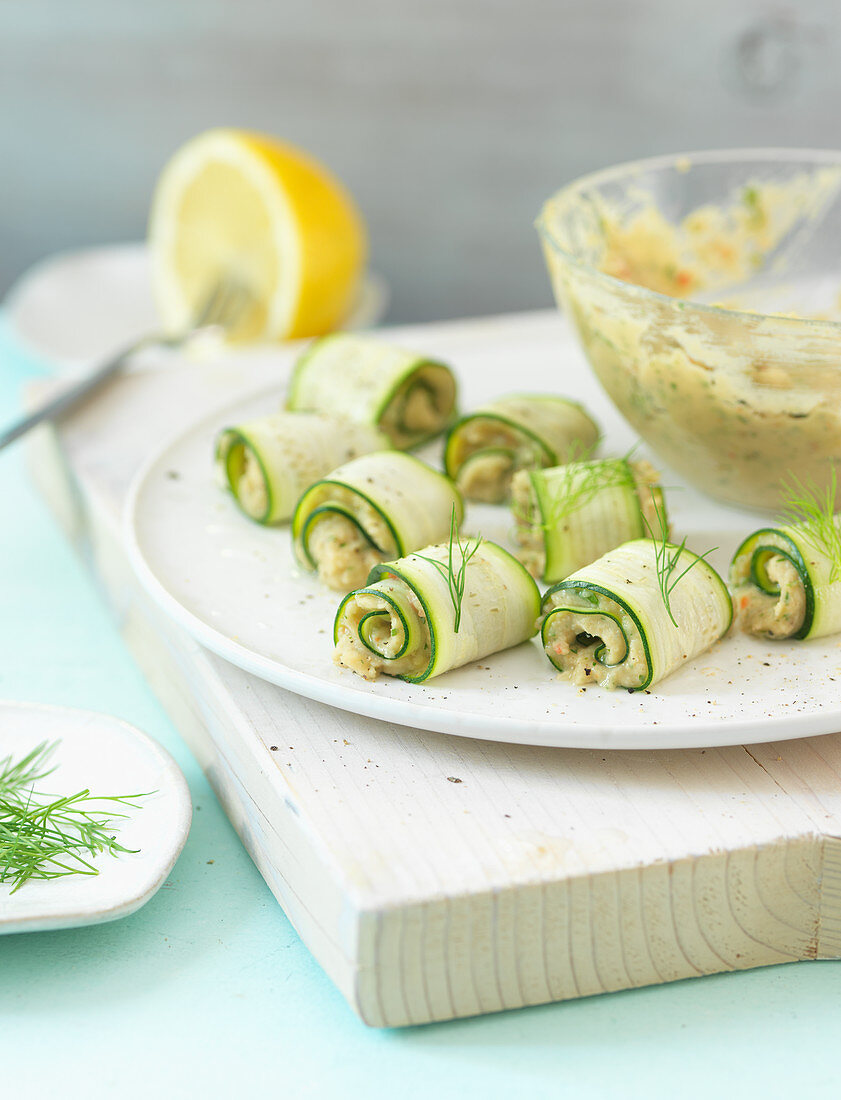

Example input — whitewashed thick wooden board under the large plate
[26,314,841,1026]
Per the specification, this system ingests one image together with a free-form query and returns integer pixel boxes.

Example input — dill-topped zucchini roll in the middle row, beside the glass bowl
[511,459,665,584]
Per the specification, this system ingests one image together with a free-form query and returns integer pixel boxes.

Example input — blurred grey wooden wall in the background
[0,0,841,321]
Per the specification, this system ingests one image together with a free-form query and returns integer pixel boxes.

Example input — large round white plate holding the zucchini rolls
[121,354,841,748]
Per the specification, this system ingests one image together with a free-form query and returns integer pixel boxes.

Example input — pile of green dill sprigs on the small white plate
[0,741,148,893]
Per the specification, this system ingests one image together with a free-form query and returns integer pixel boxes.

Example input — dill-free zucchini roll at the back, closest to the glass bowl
[444,394,599,504]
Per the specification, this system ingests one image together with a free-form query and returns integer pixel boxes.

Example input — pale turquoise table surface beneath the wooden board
[0,314,841,1100]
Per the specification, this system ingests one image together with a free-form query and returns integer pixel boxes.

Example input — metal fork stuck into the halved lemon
[0,278,250,451]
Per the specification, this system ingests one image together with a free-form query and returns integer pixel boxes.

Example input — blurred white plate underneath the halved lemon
[4,243,388,372]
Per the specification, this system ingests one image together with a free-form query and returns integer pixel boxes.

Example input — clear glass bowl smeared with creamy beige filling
[538,150,841,510]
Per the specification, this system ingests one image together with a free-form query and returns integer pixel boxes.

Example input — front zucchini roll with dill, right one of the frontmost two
[541,539,733,691]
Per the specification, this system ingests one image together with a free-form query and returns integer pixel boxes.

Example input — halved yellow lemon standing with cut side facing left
[150,130,366,340]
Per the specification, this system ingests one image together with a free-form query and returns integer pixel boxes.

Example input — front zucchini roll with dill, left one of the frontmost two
[333,539,540,683]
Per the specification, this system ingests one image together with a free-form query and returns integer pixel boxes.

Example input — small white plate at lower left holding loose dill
[0,703,191,933]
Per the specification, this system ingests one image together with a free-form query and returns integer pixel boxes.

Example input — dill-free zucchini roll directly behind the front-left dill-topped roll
[292,451,464,592]
